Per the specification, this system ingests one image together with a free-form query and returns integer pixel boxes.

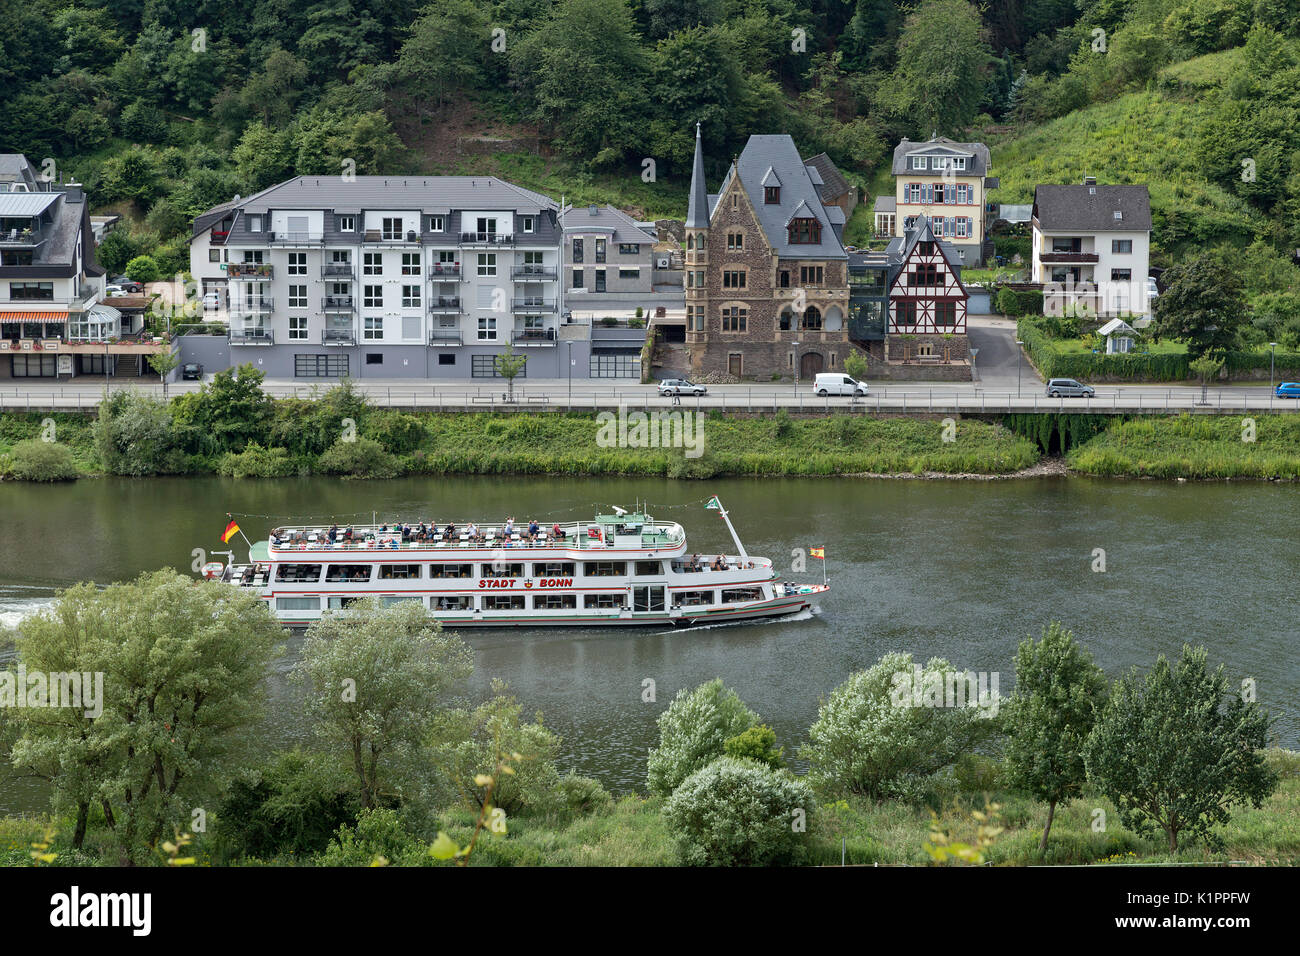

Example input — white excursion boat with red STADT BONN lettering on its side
[203,498,828,627]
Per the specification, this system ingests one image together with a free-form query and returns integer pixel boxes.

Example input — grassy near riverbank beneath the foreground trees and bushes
[0,750,1300,866]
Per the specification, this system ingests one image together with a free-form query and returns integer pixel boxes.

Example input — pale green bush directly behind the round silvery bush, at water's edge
[646,678,758,795]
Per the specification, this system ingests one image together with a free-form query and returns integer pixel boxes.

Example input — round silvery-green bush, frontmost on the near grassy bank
[663,757,814,866]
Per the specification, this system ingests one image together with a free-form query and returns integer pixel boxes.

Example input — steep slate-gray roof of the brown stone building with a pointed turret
[723,134,846,259]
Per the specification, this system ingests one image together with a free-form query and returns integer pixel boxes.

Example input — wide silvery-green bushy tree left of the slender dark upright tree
[800,653,997,800]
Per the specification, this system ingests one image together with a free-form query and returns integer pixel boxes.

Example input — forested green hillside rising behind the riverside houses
[0,0,1300,303]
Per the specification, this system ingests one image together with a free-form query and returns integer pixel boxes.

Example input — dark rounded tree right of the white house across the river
[1153,252,1247,359]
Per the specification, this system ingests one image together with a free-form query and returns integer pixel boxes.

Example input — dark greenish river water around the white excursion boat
[0,477,1300,812]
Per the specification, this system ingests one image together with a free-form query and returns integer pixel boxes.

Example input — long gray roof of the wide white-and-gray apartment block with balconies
[231,176,559,215]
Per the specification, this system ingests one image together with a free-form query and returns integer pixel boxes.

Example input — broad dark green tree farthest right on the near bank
[1084,645,1278,853]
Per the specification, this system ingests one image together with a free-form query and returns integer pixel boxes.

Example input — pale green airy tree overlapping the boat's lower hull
[293,598,473,809]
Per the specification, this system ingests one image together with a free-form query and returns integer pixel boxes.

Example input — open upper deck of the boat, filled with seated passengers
[268,514,686,557]
